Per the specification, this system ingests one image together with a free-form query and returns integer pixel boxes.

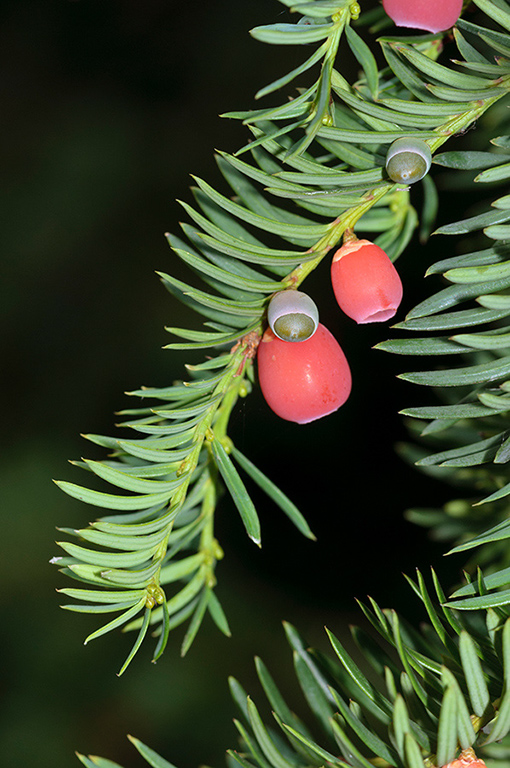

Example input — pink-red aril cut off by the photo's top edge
[383,0,462,32]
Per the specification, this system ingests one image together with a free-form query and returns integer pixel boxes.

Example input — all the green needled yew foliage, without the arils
[54,0,510,768]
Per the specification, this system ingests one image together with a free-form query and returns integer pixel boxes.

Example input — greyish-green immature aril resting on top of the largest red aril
[267,290,319,341]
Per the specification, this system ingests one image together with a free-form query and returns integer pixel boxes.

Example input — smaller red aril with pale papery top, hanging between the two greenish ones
[331,239,403,324]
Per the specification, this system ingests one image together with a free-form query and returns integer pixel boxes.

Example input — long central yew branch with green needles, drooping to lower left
[54,0,508,672]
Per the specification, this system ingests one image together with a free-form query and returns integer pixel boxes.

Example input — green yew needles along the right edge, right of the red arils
[377,130,510,592]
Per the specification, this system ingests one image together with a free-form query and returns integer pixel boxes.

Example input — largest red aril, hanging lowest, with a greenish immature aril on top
[257,323,352,424]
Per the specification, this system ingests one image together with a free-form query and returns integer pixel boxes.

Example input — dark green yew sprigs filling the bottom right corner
[76,572,510,768]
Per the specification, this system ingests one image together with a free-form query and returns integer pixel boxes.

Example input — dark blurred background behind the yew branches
[0,0,470,768]
